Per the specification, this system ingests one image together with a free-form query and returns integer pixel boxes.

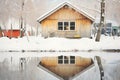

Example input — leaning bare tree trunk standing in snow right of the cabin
[95,0,105,42]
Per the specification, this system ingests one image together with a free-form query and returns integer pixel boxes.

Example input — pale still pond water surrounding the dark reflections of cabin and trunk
[0,52,120,80]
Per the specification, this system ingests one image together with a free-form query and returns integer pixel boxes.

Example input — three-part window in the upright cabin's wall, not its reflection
[58,22,75,31]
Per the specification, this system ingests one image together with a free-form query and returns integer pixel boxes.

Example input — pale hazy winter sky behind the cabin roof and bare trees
[0,0,120,27]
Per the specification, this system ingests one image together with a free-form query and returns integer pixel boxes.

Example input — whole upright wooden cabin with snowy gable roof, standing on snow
[38,2,94,38]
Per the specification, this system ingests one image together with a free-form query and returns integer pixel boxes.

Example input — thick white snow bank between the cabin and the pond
[0,35,120,51]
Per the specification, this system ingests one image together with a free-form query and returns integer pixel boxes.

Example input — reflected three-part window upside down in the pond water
[58,56,75,64]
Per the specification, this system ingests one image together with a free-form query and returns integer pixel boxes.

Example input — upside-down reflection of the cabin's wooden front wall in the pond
[40,55,93,79]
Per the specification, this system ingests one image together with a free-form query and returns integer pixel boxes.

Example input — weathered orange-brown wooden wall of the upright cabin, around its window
[41,7,92,37]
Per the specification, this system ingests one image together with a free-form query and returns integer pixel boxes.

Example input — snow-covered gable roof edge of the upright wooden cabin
[37,2,95,22]
